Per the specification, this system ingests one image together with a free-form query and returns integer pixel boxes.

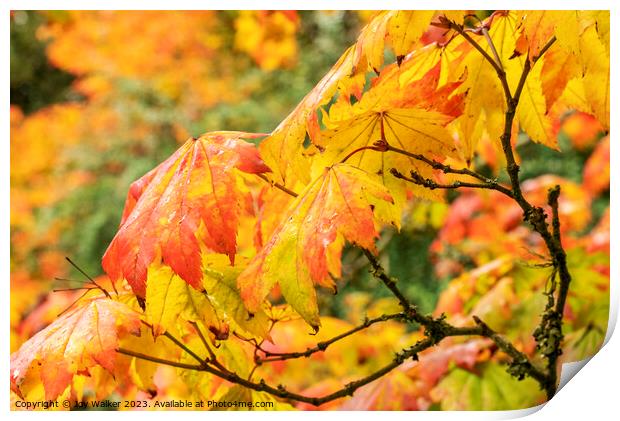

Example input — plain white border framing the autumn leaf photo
[0,0,620,420]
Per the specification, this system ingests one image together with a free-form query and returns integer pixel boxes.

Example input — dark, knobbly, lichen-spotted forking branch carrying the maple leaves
[247,29,570,405]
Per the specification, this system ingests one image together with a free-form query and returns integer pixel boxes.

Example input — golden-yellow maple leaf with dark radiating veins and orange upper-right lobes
[317,55,463,207]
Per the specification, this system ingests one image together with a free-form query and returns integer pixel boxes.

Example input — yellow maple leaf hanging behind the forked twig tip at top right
[446,11,557,149]
